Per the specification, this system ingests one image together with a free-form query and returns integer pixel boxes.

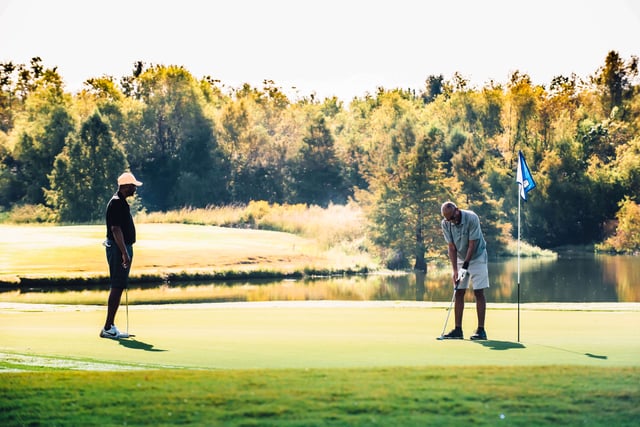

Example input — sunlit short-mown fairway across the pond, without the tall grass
[0,223,377,285]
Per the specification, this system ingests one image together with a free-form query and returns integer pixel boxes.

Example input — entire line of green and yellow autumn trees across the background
[0,51,640,268]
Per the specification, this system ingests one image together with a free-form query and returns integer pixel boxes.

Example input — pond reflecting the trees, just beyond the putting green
[5,253,640,304]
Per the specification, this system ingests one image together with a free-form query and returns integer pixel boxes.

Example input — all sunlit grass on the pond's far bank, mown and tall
[0,201,555,289]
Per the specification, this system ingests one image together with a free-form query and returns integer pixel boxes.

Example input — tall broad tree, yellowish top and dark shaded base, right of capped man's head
[125,66,228,210]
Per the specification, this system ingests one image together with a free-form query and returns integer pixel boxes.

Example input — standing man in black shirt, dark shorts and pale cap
[100,172,142,339]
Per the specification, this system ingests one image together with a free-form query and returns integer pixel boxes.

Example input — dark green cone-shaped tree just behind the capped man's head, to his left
[46,113,126,222]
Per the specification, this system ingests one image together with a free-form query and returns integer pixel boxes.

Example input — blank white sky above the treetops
[0,0,640,101]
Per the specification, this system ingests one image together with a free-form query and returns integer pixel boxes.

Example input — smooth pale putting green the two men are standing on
[0,301,640,370]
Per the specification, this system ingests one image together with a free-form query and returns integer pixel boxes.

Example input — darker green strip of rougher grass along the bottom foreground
[0,366,640,426]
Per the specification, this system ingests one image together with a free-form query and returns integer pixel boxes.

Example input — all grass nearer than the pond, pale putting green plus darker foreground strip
[0,302,640,426]
